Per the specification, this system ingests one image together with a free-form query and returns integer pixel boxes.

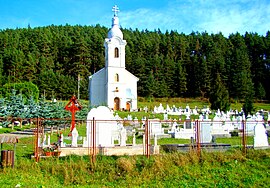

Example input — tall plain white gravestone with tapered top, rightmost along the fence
[254,122,269,147]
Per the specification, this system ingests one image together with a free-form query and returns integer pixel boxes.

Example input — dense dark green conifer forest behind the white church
[0,25,270,100]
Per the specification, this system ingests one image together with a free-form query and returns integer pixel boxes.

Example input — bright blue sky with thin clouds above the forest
[0,0,270,36]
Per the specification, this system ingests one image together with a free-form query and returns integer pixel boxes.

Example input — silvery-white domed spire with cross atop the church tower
[108,5,123,39]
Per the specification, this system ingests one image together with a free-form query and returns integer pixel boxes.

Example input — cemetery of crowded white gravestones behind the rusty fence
[29,101,269,157]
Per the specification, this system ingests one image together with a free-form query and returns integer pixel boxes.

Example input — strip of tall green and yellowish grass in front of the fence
[0,150,270,187]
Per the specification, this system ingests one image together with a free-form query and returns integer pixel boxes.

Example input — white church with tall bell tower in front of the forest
[89,5,139,111]
